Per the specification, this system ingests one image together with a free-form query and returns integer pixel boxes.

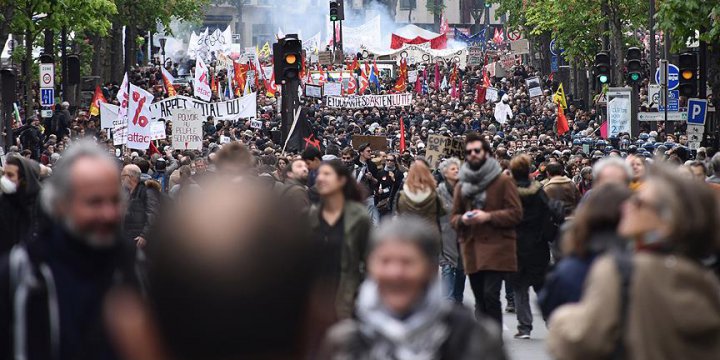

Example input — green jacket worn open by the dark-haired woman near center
[310,201,370,319]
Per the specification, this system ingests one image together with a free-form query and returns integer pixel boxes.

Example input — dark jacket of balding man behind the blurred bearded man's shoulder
[123,182,160,242]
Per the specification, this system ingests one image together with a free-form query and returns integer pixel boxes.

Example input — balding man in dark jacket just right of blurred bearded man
[120,164,160,249]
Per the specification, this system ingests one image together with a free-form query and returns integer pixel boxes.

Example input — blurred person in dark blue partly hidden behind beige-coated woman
[538,184,631,318]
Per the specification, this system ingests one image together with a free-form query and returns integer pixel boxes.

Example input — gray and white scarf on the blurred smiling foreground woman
[357,280,452,360]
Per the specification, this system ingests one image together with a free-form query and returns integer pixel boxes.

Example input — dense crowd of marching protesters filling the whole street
[0,59,720,360]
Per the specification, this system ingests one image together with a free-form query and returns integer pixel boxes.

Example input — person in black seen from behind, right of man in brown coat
[509,155,550,339]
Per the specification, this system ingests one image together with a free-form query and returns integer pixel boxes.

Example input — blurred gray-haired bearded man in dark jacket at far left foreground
[0,142,135,360]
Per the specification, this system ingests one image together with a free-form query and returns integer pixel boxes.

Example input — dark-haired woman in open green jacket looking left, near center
[309,160,370,318]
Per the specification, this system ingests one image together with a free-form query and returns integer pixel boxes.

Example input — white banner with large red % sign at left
[127,84,154,150]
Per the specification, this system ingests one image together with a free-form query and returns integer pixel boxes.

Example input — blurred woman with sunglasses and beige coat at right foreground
[548,168,720,360]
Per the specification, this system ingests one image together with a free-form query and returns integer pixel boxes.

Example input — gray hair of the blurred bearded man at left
[40,140,116,217]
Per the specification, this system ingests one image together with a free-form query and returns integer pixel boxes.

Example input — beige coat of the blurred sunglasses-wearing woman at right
[547,253,720,360]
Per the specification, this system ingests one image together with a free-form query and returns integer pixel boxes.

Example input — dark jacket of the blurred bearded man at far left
[0,223,138,360]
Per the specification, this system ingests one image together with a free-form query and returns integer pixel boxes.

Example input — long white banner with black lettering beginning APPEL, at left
[150,93,257,121]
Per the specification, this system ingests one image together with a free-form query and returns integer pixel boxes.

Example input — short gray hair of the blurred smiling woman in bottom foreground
[370,215,440,266]
